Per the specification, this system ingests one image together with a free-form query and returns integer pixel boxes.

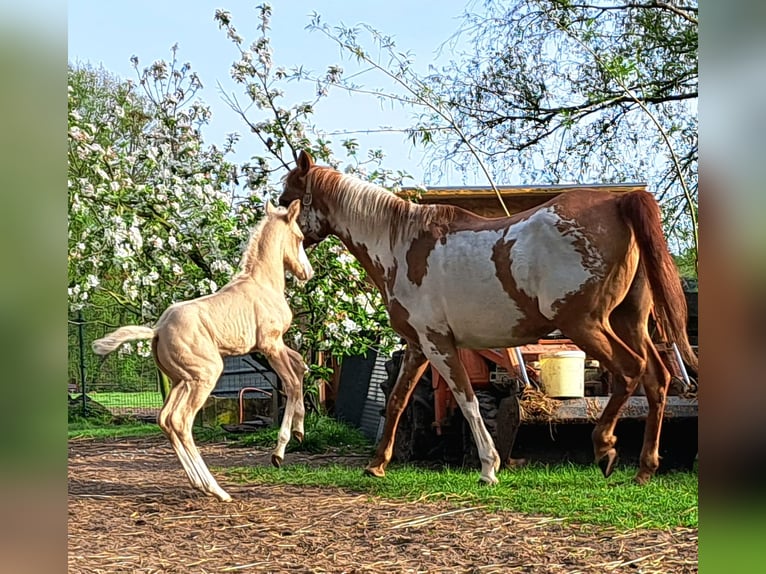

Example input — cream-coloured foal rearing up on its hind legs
[93,201,314,501]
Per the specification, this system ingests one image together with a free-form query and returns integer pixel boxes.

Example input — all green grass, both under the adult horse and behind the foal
[69,415,698,530]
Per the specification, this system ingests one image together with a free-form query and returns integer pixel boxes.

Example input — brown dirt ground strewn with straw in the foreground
[68,438,697,574]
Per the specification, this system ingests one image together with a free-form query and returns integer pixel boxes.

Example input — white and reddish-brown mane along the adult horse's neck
[311,167,457,245]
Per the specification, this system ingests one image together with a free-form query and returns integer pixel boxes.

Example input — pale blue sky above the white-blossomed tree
[68,0,468,185]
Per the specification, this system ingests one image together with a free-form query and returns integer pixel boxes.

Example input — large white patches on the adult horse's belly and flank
[395,209,601,348]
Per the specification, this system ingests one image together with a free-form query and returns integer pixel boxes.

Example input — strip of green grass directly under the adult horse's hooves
[224,463,698,530]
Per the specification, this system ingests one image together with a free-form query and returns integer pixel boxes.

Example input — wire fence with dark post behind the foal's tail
[67,310,162,419]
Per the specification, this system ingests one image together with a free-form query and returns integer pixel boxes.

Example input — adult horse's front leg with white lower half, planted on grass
[424,336,500,484]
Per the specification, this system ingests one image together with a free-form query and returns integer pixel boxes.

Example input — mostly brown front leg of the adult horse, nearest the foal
[364,341,428,477]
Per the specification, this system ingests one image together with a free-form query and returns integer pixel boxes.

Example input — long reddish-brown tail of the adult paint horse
[619,191,698,372]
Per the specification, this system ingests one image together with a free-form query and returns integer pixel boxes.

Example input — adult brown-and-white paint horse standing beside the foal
[280,152,697,484]
